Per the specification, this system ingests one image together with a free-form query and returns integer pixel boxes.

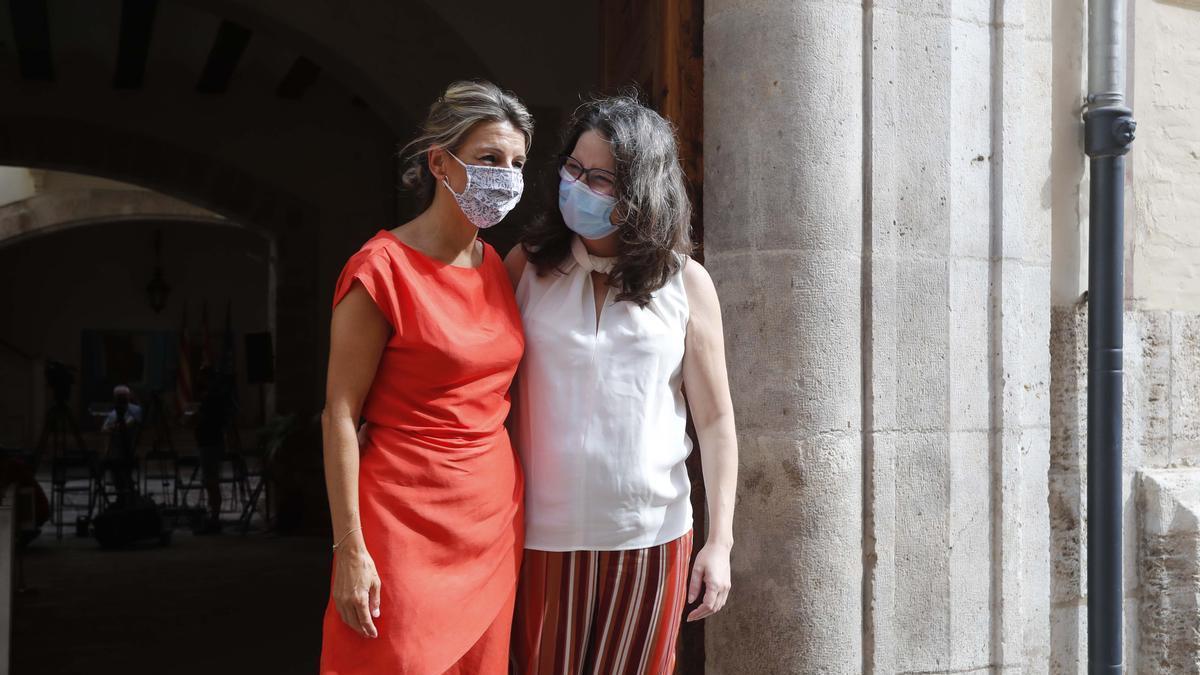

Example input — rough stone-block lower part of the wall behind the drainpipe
[1050,303,1200,674]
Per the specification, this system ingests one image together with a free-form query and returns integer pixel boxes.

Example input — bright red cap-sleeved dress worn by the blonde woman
[320,231,524,675]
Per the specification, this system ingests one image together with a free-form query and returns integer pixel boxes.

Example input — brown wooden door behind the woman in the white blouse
[600,0,704,675]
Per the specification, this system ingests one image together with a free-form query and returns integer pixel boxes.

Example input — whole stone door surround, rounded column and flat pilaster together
[704,0,1052,674]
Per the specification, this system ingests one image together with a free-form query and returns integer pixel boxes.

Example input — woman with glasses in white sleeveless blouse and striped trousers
[505,97,737,675]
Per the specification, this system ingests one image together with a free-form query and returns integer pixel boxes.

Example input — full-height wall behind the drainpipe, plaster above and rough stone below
[1050,0,1200,674]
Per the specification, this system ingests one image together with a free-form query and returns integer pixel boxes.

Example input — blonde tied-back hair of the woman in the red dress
[400,79,533,211]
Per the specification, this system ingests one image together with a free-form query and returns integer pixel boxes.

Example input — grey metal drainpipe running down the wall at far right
[1084,0,1136,675]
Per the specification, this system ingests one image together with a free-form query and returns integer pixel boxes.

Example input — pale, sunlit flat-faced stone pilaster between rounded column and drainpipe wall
[863,0,1050,674]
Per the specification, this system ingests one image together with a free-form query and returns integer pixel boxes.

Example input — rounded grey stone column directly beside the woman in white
[704,0,863,675]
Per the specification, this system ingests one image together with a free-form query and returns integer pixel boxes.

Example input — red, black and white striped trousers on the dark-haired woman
[511,532,692,675]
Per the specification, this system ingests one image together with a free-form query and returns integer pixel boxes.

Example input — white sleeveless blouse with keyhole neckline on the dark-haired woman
[514,238,691,551]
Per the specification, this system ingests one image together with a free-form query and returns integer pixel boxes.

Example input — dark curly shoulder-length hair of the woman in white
[521,95,691,306]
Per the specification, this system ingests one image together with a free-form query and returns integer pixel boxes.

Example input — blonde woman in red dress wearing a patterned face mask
[320,82,533,675]
